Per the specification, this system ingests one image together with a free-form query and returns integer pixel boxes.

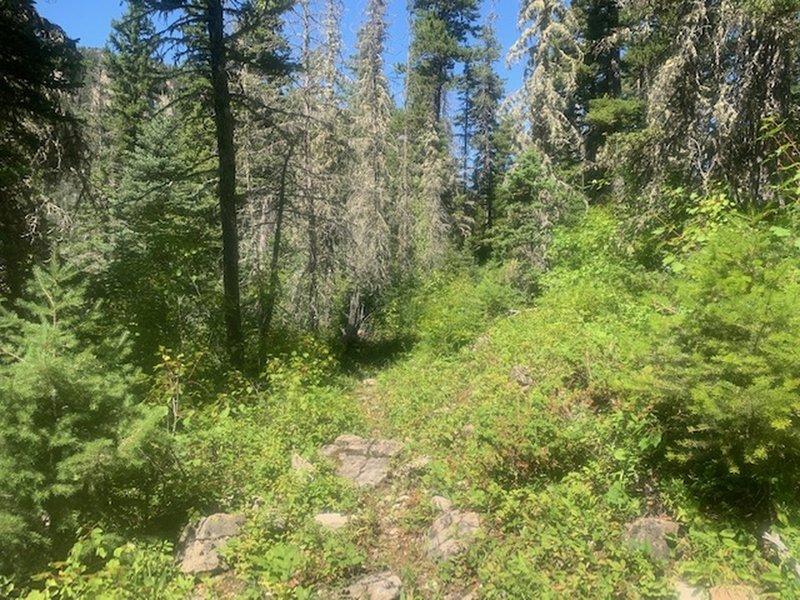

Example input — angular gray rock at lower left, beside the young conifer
[178,513,245,575]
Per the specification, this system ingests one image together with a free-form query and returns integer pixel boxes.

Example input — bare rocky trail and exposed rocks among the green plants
[178,380,758,600]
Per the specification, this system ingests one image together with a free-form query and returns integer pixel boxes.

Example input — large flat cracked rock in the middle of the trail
[322,435,403,487]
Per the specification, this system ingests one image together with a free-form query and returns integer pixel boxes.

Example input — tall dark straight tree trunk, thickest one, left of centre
[206,0,244,369]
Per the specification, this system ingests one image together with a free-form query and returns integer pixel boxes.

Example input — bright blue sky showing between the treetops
[36,0,522,90]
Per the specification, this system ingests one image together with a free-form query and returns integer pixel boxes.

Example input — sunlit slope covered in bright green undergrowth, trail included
[7,209,800,598]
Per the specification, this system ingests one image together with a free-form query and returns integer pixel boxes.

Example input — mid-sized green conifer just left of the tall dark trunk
[103,112,219,366]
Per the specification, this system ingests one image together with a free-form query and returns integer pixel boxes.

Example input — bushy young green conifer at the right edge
[644,219,800,508]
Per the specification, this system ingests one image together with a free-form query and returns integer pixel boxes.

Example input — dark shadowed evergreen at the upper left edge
[0,0,83,300]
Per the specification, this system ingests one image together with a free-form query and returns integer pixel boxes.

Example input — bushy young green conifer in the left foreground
[0,259,175,572]
